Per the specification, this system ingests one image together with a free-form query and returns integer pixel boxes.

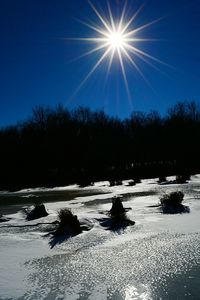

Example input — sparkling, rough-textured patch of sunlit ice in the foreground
[21,227,200,300]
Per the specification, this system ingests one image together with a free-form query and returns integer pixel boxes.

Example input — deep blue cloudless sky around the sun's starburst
[0,0,200,126]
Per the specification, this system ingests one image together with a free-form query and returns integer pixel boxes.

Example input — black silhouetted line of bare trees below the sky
[0,102,200,190]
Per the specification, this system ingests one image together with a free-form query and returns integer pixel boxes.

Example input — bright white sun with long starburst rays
[70,0,166,96]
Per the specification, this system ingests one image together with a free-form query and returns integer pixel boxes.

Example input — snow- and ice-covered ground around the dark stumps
[0,175,200,300]
